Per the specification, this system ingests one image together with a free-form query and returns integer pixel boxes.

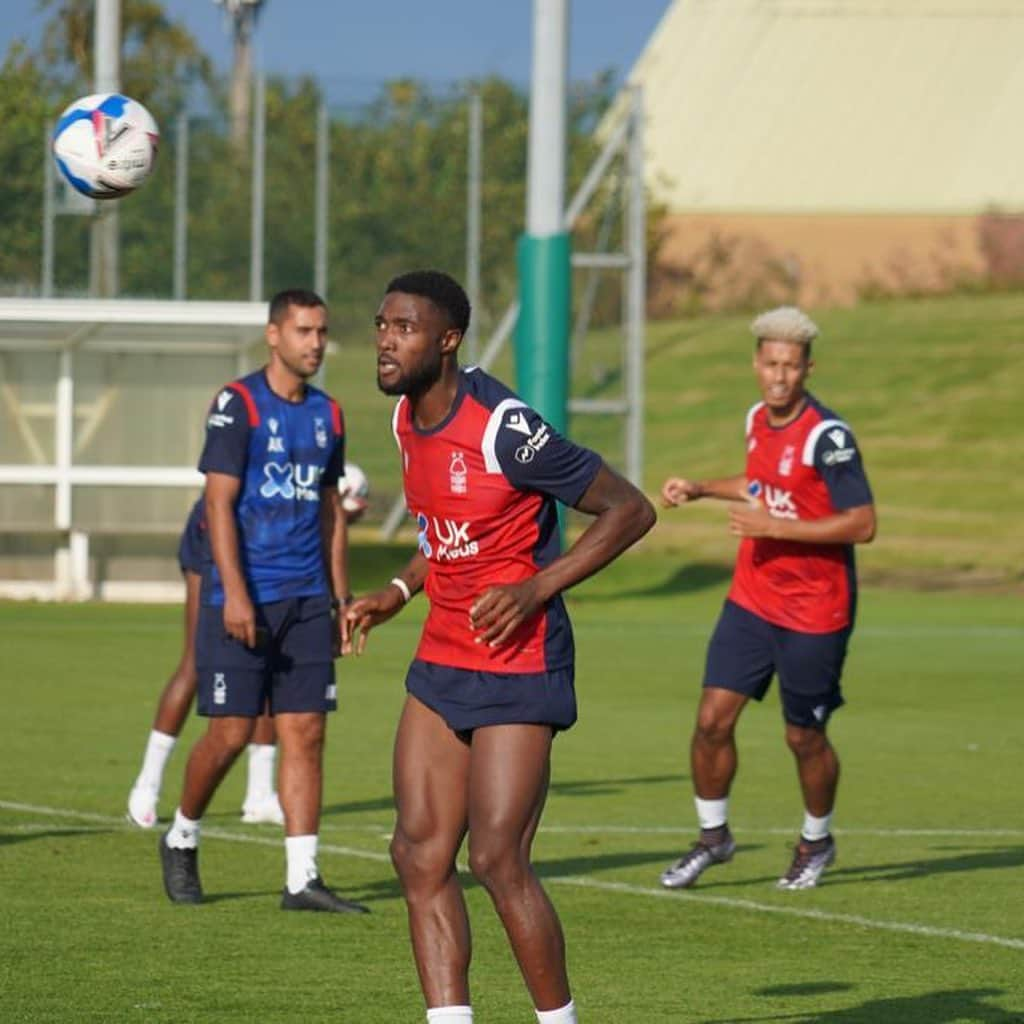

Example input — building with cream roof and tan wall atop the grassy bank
[629,0,1024,313]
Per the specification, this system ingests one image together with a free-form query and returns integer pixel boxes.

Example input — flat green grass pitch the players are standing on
[0,548,1024,1024]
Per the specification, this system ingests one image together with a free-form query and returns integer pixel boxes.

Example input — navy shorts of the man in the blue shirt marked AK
[196,595,338,718]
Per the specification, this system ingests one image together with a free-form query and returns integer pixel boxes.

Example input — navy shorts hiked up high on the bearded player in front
[406,658,577,733]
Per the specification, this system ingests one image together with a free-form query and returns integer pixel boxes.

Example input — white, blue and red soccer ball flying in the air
[53,92,160,199]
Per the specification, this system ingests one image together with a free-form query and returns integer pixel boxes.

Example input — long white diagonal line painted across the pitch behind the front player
[0,800,1024,950]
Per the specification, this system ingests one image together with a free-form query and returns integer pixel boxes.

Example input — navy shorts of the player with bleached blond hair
[703,601,851,728]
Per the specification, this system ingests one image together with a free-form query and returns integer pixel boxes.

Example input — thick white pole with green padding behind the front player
[515,0,571,432]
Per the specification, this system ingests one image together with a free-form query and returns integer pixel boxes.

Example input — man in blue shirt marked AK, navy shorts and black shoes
[160,290,366,912]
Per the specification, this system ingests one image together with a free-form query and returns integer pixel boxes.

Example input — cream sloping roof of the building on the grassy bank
[629,0,1024,213]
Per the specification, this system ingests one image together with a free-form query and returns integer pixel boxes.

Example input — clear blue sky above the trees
[6,0,671,99]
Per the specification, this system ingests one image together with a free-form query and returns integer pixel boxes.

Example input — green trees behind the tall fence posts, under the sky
[0,0,612,307]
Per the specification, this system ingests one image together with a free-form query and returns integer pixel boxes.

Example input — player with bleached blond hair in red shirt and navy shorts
[662,306,874,890]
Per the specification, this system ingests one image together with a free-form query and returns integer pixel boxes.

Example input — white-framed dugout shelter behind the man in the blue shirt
[0,299,266,601]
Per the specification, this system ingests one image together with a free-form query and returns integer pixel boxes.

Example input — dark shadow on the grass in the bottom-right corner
[694,983,1024,1024]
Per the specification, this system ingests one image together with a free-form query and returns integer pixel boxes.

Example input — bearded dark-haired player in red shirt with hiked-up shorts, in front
[347,270,654,1024]
